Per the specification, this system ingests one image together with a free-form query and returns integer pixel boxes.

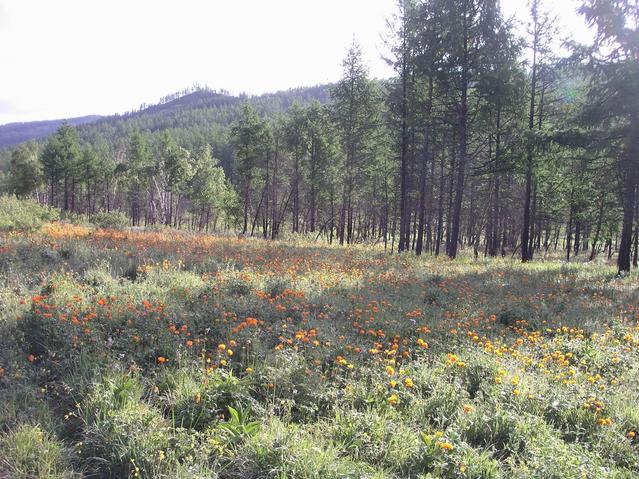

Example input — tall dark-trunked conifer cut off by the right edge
[579,0,639,273]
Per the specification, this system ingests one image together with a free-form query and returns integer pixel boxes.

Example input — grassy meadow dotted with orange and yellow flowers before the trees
[0,223,639,479]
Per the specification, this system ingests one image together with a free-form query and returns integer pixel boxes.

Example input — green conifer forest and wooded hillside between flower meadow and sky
[2,0,639,272]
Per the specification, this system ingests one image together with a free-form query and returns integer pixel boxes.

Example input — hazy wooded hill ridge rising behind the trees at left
[0,85,330,171]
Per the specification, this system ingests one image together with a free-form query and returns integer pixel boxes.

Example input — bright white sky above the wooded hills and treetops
[0,0,586,124]
